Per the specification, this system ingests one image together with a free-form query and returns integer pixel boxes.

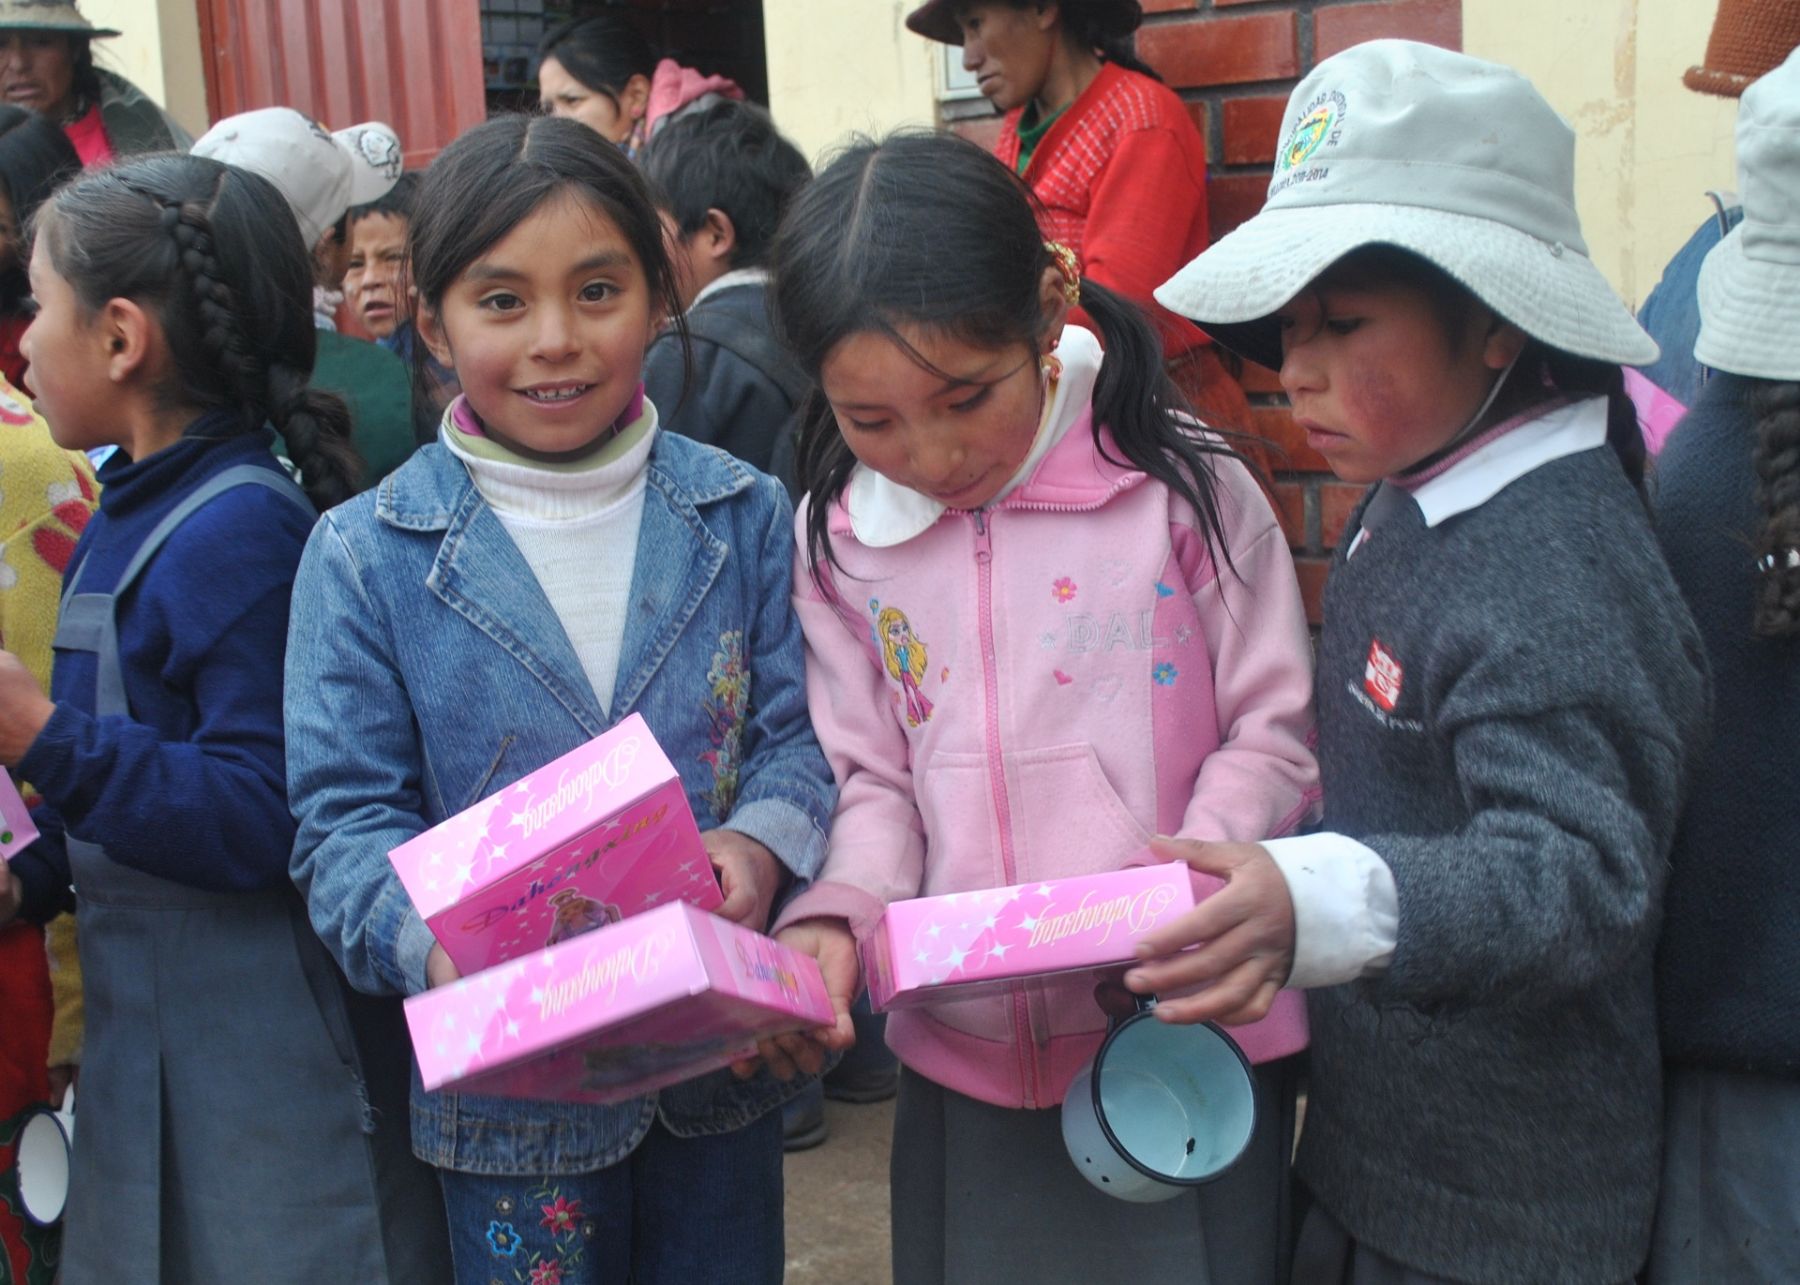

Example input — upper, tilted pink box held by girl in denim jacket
[387,714,724,975]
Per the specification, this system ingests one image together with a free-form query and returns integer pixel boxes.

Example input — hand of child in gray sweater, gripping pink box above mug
[1125,839,1294,1026]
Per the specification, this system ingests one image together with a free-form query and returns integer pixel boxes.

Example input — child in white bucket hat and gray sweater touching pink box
[1127,41,1706,1283]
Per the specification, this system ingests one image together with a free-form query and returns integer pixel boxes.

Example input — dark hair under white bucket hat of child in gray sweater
[1321,243,1647,497]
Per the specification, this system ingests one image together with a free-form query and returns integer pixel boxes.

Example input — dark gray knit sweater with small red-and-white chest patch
[1298,446,1708,1285]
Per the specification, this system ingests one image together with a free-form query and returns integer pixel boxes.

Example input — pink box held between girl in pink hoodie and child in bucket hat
[860,862,1193,1011]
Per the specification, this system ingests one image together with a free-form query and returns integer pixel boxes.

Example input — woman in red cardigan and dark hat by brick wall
[905,0,1249,428]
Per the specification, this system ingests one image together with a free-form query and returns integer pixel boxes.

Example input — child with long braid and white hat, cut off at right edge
[1649,42,1800,1285]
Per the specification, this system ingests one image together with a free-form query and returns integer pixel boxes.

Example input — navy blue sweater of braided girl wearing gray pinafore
[13,418,311,918]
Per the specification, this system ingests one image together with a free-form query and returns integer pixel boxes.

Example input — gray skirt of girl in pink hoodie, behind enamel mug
[889,1058,1300,1285]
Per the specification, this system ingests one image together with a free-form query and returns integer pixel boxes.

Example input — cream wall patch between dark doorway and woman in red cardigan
[763,0,938,160]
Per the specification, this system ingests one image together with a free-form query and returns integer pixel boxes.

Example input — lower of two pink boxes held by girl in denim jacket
[405,902,833,1101]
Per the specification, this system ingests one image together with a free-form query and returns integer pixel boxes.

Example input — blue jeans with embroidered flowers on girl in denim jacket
[439,1110,787,1285]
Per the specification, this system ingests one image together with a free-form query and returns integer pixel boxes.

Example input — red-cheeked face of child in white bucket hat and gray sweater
[1276,272,1525,482]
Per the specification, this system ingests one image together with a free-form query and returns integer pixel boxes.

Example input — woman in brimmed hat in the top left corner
[0,0,193,166]
